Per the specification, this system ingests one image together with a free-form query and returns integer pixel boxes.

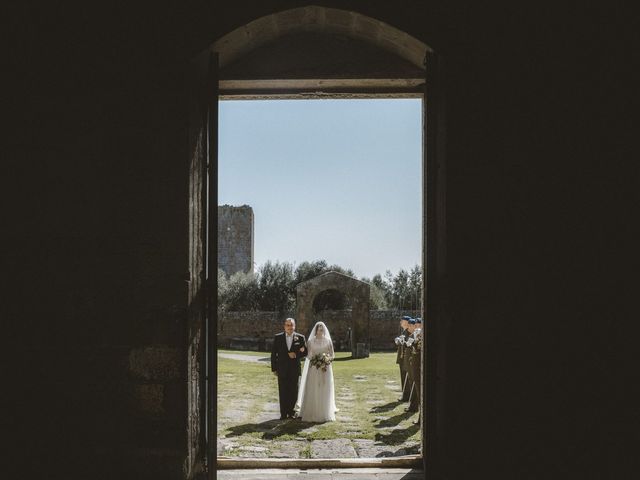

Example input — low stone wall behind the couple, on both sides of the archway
[218,310,420,351]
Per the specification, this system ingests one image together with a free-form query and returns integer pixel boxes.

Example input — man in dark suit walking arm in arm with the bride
[271,318,307,420]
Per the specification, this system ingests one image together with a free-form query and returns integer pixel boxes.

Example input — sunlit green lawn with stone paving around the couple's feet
[218,350,420,457]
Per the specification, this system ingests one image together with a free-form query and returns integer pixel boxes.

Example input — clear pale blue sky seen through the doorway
[218,99,422,277]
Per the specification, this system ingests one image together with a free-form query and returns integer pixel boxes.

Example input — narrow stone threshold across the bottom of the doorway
[216,455,422,470]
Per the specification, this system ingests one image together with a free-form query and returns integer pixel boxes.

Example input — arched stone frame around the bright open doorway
[188,6,445,478]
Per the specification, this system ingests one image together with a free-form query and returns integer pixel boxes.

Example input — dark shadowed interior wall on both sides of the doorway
[7,0,638,479]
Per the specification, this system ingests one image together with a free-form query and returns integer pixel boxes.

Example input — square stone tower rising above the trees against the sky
[218,205,254,276]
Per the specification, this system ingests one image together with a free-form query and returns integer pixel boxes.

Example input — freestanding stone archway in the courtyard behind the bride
[296,271,371,358]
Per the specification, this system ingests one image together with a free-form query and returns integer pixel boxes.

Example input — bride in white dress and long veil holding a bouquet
[296,322,338,422]
